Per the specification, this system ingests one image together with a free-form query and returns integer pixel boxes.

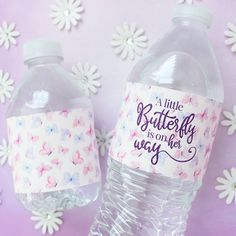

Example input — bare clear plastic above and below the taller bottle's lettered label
[89,15,224,236]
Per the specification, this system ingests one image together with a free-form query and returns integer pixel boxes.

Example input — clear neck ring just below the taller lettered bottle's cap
[172,17,208,31]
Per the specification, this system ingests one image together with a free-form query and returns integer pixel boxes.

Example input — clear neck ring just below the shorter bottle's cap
[25,56,63,68]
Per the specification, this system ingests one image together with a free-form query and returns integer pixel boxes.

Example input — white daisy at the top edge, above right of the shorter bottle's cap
[50,0,84,31]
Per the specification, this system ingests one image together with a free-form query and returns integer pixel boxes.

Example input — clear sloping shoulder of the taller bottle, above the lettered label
[130,27,224,102]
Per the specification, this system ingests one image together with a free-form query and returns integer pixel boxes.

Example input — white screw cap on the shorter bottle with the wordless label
[23,39,63,62]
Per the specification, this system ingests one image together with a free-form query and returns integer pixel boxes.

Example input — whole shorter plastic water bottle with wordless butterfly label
[7,39,101,211]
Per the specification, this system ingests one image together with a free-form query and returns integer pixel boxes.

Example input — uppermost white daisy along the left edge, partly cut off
[0,21,20,50]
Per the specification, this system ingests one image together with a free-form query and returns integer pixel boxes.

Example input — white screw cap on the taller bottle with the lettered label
[173,4,212,27]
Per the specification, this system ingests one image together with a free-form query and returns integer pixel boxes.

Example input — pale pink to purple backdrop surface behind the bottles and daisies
[0,0,236,236]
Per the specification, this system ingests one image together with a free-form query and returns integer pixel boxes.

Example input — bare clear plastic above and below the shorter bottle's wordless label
[7,57,101,211]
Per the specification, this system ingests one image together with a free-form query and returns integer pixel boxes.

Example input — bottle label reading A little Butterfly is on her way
[109,83,221,181]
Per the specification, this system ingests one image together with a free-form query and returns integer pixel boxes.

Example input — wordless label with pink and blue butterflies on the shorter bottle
[7,108,100,193]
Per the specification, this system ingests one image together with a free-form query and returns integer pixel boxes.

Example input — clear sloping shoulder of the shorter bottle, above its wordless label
[7,65,91,117]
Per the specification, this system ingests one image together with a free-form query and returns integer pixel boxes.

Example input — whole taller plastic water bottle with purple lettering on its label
[90,5,224,236]
